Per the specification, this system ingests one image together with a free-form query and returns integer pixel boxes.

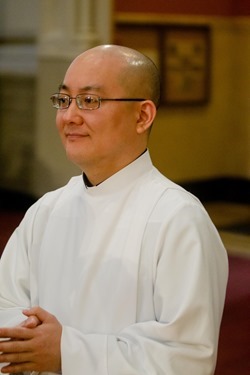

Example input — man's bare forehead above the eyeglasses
[63,53,123,92]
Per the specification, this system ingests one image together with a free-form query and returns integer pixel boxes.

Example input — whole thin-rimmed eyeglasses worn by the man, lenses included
[50,93,146,111]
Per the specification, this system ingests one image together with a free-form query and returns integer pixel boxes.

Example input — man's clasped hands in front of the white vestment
[0,307,62,374]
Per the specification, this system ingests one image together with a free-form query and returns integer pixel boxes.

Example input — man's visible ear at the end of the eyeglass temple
[136,100,156,134]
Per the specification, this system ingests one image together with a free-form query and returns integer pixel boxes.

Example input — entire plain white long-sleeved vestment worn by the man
[0,152,228,375]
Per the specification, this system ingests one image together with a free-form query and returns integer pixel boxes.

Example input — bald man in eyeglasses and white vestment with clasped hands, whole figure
[0,45,228,375]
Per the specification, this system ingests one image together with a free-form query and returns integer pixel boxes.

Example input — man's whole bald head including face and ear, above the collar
[56,45,159,185]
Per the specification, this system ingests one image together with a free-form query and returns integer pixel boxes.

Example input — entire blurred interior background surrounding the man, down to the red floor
[0,0,250,375]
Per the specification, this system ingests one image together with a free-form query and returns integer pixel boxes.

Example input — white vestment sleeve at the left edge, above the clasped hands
[0,203,44,327]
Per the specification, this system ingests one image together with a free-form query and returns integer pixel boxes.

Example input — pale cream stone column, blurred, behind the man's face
[33,0,113,196]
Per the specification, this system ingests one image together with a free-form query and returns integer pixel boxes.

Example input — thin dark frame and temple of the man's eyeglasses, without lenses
[50,92,147,111]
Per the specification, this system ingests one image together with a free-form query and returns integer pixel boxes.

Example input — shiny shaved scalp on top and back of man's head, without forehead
[73,45,160,107]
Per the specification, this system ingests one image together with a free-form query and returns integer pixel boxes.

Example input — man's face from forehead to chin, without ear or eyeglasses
[56,53,144,182]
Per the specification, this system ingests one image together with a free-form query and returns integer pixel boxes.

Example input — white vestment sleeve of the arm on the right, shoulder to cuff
[62,204,228,375]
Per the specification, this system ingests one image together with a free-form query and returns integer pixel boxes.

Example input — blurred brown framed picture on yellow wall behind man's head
[160,25,210,105]
